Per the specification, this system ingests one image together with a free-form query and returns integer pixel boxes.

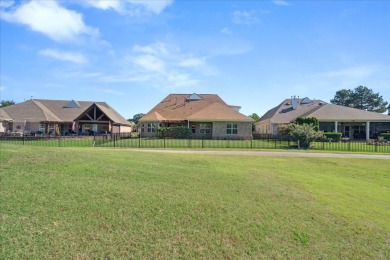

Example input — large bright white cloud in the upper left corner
[1,1,99,42]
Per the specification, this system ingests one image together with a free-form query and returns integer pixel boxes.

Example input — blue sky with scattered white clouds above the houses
[0,0,390,118]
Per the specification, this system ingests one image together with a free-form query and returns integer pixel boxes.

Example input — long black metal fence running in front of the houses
[0,134,390,153]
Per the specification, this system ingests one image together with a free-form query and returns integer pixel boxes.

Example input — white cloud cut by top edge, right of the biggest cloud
[87,0,173,15]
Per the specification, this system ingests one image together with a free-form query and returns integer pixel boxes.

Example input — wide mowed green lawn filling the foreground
[0,144,390,259]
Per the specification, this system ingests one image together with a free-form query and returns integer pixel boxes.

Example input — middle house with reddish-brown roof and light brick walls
[138,93,253,139]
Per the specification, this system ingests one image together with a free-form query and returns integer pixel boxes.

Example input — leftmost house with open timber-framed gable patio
[0,99,132,135]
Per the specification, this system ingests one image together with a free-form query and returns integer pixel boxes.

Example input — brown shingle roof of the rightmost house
[259,98,390,124]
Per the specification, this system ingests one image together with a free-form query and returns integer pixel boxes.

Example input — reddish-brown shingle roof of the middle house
[140,94,252,122]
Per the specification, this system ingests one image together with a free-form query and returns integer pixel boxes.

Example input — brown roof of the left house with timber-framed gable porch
[4,99,129,125]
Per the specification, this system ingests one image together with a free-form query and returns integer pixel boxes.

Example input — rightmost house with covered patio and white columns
[255,97,390,140]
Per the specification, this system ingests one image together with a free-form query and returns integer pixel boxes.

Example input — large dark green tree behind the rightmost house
[330,86,388,113]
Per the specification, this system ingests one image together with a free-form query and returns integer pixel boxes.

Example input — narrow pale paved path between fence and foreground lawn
[129,149,390,160]
